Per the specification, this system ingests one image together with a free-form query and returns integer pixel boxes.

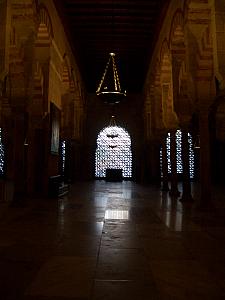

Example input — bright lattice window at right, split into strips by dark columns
[160,130,194,179]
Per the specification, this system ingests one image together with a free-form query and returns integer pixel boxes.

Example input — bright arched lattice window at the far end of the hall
[95,126,132,178]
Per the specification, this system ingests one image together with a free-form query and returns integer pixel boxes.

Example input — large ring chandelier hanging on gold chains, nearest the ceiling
[96,53,126,104]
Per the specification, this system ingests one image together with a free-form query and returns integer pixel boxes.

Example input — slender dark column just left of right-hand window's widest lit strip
[170,129,180,197]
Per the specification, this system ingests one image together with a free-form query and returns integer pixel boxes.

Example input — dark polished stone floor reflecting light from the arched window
[0,181,225,300]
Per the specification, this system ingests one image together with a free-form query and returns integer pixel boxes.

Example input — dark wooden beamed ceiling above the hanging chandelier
[55,0,169,93]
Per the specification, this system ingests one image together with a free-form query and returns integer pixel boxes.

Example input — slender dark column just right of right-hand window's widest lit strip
[180,128,193,202]
